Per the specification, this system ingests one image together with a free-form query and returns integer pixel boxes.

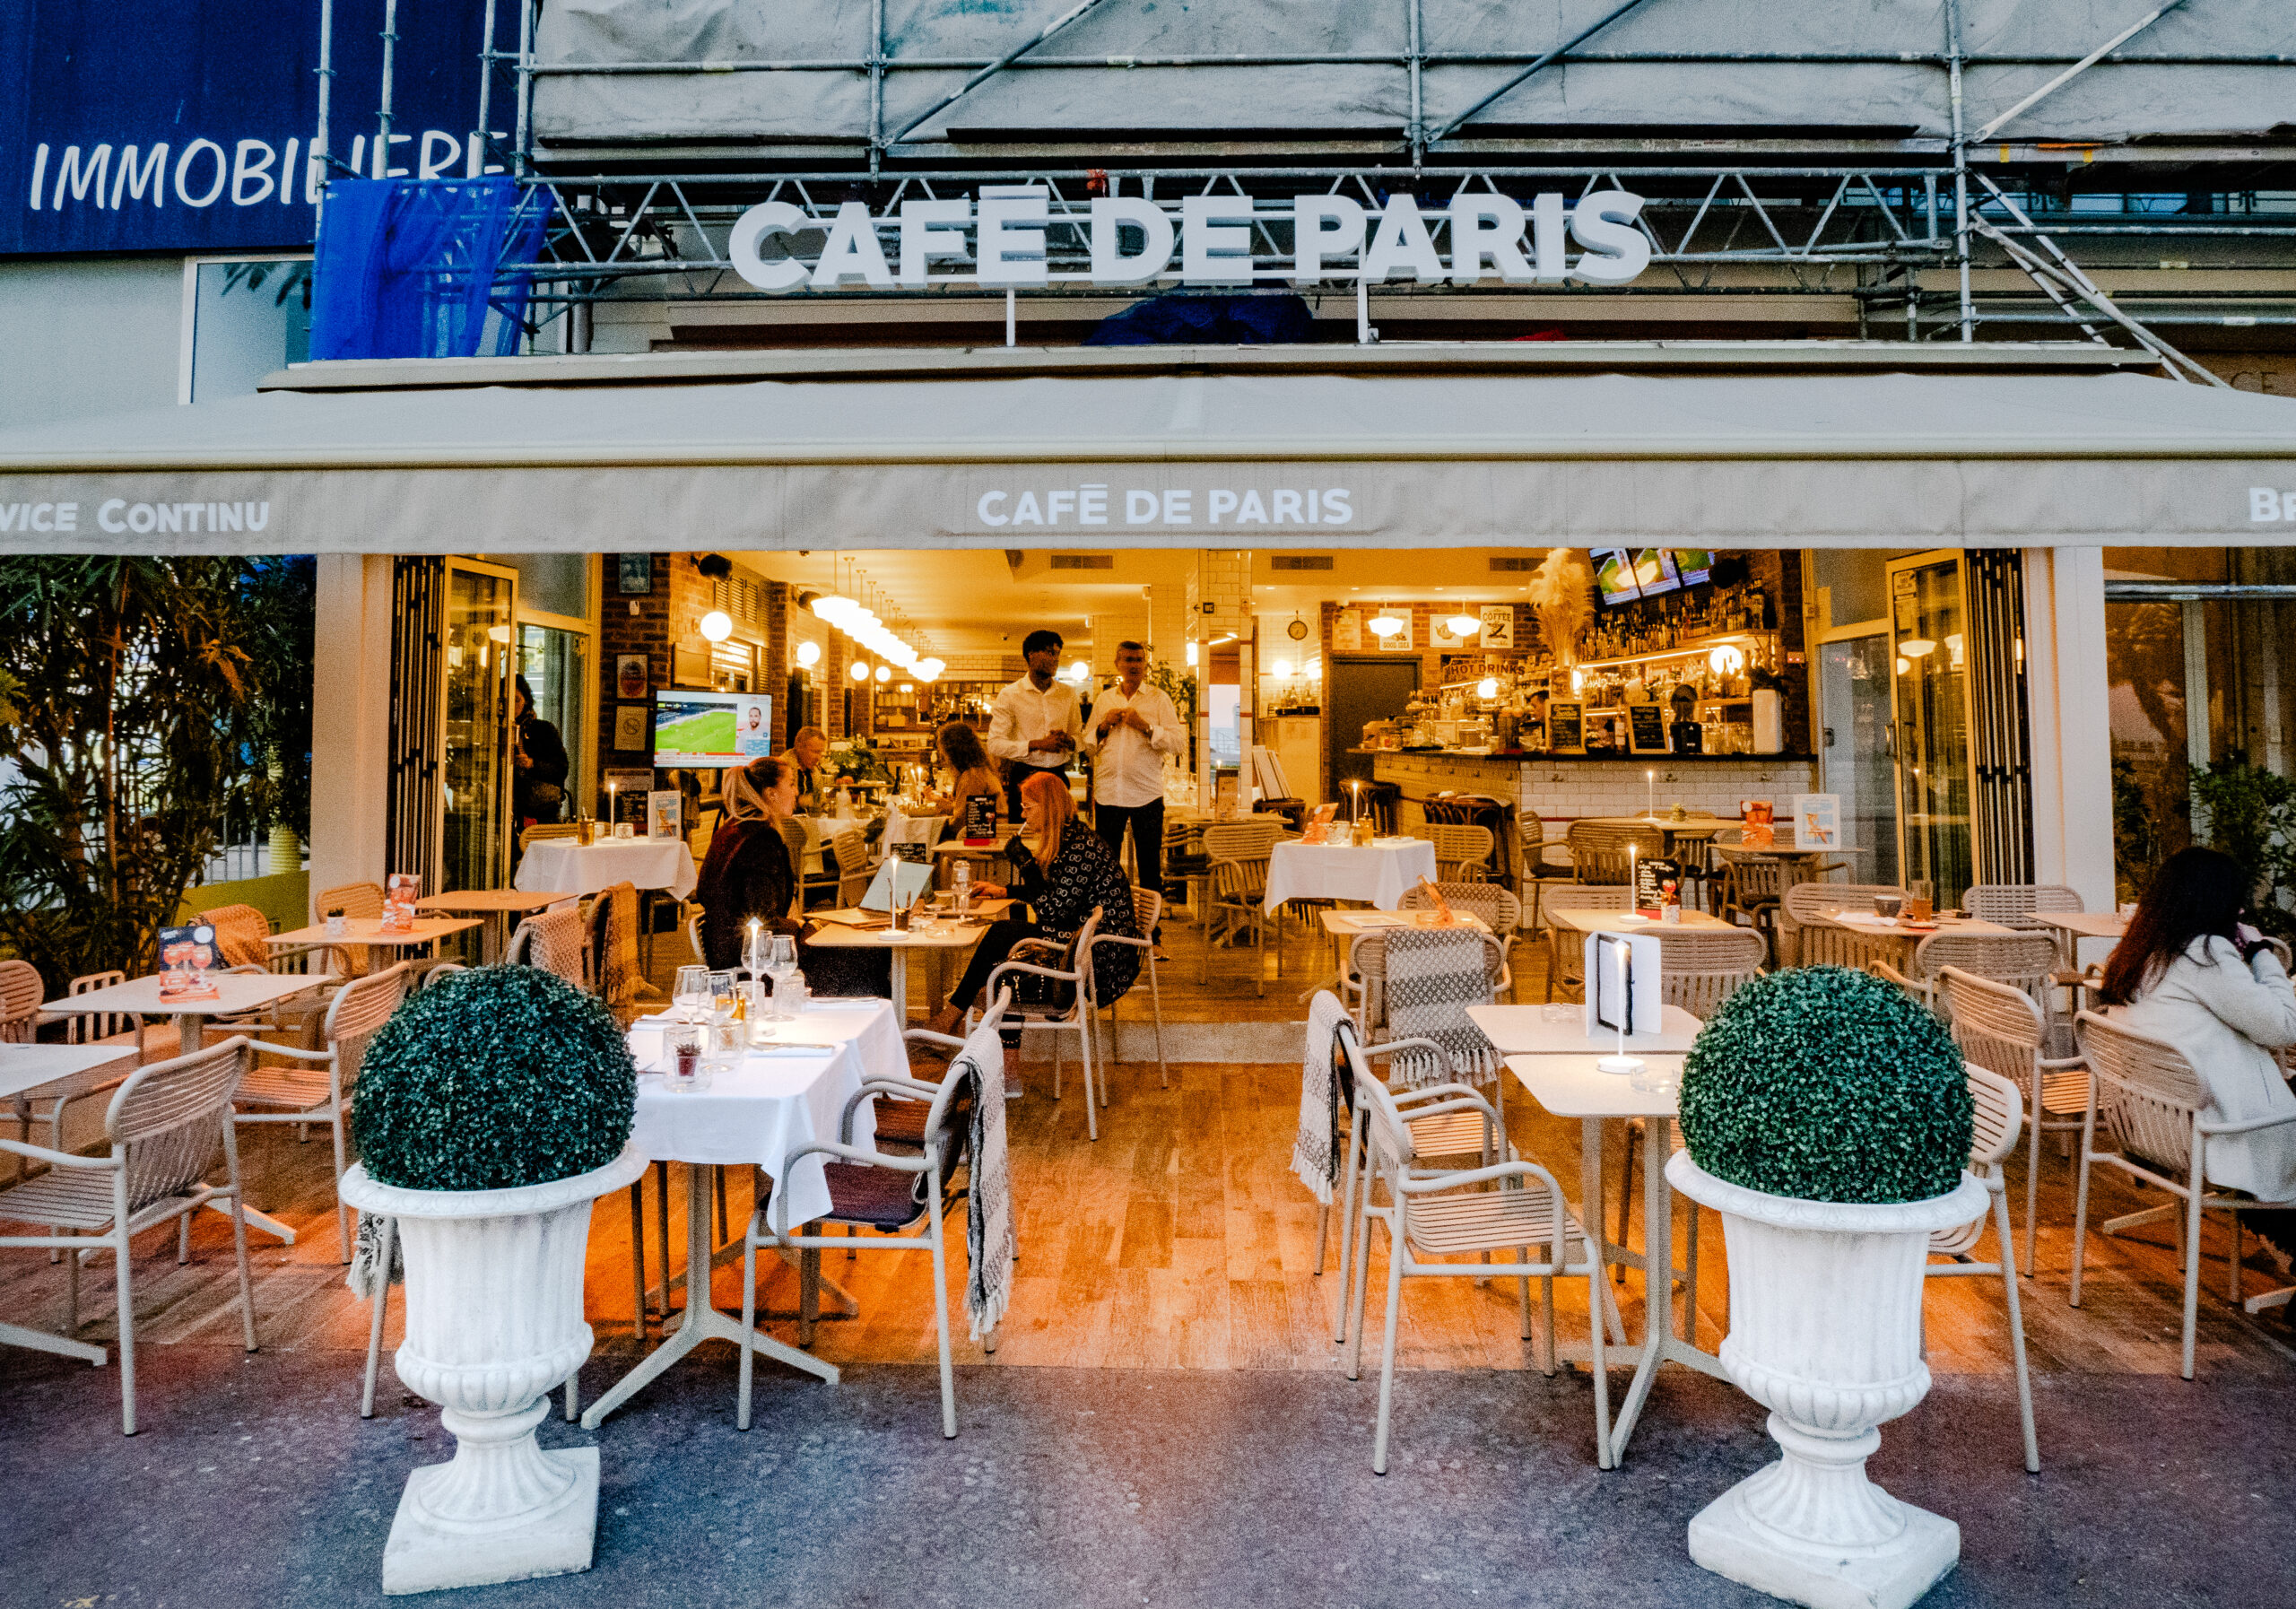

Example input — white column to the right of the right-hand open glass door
[2025,549,2112,911]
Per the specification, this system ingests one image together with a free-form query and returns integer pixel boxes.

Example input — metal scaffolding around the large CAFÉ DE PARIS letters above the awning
[344,0,2296,362]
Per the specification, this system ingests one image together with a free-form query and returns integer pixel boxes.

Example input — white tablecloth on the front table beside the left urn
[629,1001,909,1223]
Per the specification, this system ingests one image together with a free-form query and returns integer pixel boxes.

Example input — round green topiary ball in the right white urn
[1681,966,1975,1203]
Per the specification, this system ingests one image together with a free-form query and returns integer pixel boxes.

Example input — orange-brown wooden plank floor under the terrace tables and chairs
[0,1014,2296,1379]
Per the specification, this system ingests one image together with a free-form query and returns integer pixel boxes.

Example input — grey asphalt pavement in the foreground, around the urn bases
[0,1345,2296,1609]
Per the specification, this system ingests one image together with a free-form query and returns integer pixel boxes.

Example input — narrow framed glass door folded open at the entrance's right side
[1890,553,1970,909]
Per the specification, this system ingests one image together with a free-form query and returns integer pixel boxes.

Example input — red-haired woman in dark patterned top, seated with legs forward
[932,771,1141,1079]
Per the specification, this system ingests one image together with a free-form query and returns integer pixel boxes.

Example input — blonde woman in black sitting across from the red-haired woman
[693,755,893,996]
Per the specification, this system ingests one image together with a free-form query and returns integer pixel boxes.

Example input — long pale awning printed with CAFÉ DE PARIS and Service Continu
[0,344,2296,553]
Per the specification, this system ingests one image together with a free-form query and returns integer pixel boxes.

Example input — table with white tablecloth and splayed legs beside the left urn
[581,1001,909,1430]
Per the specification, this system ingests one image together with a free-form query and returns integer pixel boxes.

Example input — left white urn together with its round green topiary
[342,966,645,1593]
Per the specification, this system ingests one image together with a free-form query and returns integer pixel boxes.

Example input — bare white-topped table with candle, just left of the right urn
[1506,1046,1729,1466]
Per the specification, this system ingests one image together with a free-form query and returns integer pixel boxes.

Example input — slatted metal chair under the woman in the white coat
[2071,1013,2296,1379]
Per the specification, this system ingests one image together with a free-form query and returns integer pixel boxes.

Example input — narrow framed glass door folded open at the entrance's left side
[436,560,519,893]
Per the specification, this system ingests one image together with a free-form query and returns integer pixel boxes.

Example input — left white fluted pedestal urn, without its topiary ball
[342,1148,645,1593]
